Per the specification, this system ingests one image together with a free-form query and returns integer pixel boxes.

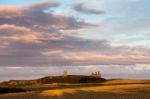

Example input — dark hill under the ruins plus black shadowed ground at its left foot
[0,75,106,93]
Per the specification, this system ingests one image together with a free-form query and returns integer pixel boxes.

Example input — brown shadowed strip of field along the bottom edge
[0,91,150,99]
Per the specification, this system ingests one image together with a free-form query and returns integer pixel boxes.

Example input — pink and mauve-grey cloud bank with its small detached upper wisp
[0,3,150,67]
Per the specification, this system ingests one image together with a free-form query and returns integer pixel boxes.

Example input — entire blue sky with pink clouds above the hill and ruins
[0,0,150,81]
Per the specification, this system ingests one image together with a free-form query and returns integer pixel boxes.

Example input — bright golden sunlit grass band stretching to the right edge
[41,84,150,96]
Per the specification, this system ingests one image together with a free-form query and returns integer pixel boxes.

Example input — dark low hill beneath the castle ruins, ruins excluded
[0,75,106,86]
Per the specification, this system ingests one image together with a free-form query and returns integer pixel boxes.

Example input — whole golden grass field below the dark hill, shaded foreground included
[0,80,150,99]
